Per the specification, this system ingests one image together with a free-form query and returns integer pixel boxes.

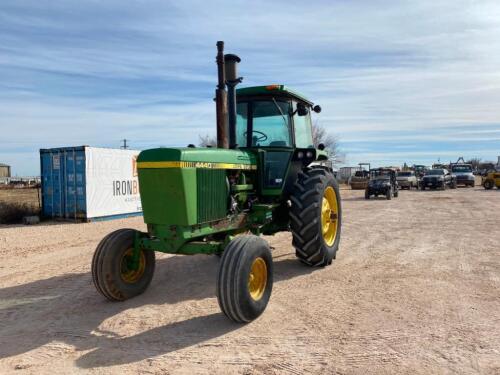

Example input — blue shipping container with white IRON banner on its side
[40,146,142,221]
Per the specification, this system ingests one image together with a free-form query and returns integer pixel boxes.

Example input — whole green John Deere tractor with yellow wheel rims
[92,42,342,322]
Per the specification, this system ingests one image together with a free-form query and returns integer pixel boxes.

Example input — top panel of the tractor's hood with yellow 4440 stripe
[137,147,257,169]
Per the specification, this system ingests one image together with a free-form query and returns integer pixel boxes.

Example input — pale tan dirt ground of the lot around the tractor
[0,187,500,374]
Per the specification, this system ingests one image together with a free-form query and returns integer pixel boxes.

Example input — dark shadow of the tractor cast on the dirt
[0,254,316,368]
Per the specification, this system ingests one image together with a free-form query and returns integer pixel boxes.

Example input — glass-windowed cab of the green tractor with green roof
[235,85,328,195]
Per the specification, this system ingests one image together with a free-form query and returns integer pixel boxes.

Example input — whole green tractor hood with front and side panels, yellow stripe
[137,147,257,226]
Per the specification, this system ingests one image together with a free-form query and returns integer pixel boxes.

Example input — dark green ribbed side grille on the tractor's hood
[196,169,228,223]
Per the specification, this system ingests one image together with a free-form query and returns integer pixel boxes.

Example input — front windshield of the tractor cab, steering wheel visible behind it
[236,99,292,147]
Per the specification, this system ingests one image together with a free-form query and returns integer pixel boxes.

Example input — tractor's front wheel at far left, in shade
[92,229,155,301]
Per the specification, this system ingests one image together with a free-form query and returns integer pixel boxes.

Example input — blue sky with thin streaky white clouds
[0,0,500,175]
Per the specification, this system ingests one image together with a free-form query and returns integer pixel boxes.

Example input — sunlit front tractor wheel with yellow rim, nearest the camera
[217,235,273,323]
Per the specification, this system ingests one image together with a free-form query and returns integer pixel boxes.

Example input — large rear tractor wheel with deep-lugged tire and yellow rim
[289,167,342,267]
